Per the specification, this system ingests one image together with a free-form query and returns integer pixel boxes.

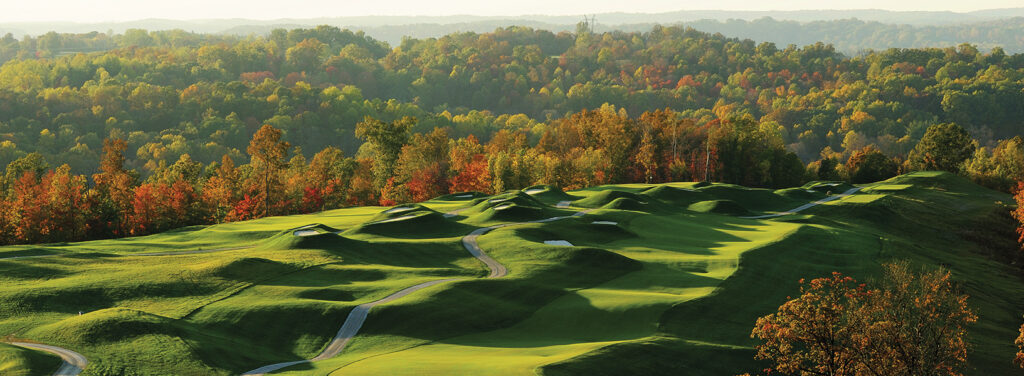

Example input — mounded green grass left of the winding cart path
[0,208,485,375]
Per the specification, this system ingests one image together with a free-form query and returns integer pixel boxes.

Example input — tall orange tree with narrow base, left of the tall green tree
[246,124,292,216]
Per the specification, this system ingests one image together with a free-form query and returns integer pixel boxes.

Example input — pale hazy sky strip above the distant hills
[0,0,1024,23]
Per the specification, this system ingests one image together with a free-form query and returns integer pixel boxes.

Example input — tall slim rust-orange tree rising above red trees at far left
[90,138,135,236]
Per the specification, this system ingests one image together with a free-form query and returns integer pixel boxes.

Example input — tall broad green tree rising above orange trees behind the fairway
[355,116,416,187]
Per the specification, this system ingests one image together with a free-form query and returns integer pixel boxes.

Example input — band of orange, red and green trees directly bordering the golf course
[0,105,1007,244]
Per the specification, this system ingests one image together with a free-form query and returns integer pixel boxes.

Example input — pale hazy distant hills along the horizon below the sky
[6,8,1024,54]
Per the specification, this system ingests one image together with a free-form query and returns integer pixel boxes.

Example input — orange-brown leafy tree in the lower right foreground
[751,263,977,376]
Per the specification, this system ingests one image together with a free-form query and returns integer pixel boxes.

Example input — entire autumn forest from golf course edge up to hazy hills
[0,25,1024,243]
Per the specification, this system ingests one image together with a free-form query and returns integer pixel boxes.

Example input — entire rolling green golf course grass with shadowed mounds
[0,172,1024,375]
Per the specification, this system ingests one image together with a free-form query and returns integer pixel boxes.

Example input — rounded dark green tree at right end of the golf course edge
[910,123,975,173]
